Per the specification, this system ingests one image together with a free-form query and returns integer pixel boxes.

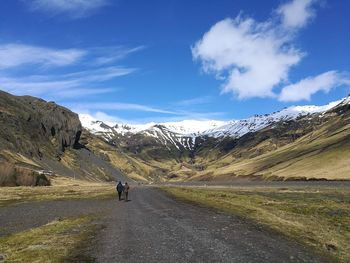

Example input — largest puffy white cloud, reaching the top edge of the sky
[192,0,326,99]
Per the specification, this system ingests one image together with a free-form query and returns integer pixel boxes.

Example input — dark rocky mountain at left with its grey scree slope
[0,91,127,185]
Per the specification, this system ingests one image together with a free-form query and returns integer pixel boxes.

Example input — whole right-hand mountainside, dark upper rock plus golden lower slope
[190,98,350,183]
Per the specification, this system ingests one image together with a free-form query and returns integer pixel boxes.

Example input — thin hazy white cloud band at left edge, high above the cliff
[0,44,86,69]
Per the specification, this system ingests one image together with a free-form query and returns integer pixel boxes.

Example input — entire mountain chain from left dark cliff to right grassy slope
[0,88,350,185]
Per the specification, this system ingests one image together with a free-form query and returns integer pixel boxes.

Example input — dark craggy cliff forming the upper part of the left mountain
[0,91,82,158]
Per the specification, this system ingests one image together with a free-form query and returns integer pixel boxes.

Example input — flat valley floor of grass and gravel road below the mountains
[0,183,349,262]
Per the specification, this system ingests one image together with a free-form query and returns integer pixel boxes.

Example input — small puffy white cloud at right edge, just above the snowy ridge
[279,71,350,101]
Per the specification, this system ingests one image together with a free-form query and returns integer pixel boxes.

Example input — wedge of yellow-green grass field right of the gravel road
[162,187,350,262]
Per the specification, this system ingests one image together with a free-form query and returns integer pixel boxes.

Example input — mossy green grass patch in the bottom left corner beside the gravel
[0,217,94,263]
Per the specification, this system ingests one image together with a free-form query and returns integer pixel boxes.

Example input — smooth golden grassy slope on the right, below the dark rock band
[192,113,350,180]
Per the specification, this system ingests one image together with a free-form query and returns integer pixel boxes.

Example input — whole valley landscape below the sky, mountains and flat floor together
[0,92,350,262]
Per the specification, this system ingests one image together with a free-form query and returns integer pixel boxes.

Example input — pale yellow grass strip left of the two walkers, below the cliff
[0,177,115,207]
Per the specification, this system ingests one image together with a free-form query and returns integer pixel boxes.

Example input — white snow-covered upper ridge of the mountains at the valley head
[79,96,350,150]
